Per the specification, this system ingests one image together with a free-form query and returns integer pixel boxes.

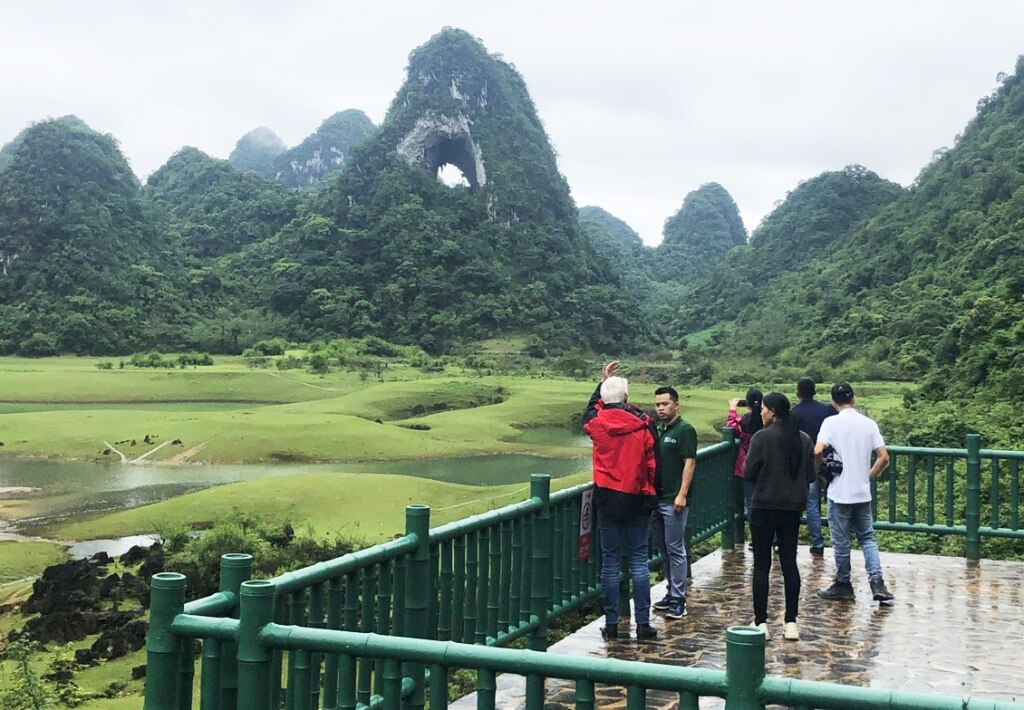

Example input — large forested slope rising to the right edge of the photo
[680,57,1024,443]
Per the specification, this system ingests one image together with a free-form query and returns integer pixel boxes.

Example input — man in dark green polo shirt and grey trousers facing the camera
[651,387,697,619]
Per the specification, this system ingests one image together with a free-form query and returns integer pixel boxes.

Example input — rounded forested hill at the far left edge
[0,117,186,354]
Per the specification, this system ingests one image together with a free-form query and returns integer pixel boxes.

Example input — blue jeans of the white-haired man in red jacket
[597,511,650,625]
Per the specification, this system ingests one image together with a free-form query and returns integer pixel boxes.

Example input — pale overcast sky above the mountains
[0,0,1024,244]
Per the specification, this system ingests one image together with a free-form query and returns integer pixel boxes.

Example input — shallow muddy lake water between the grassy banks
[0,429,590,534]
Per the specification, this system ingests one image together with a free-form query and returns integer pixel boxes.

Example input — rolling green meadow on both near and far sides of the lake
[0,357,905,540]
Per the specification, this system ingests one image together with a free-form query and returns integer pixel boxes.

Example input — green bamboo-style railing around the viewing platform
[144,430,1024,710]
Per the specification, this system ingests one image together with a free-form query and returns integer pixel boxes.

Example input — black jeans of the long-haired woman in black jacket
[751,508,800,624]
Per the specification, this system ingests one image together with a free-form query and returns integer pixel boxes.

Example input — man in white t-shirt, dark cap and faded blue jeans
[814,382,893,603]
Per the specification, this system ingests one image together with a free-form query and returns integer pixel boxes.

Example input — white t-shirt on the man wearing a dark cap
[818,407,886,503]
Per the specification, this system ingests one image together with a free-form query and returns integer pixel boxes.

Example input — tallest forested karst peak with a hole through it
[229,30,646,352]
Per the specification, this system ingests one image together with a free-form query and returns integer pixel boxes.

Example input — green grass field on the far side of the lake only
[0,358,757,463]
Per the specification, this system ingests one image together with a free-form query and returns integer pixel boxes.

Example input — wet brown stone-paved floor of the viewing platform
[452,547,1024,710]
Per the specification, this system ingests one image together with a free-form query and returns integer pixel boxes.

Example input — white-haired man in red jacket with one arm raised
[583,362,657,641]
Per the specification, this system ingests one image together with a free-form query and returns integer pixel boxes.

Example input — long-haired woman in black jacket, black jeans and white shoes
[743,392,814,640]
